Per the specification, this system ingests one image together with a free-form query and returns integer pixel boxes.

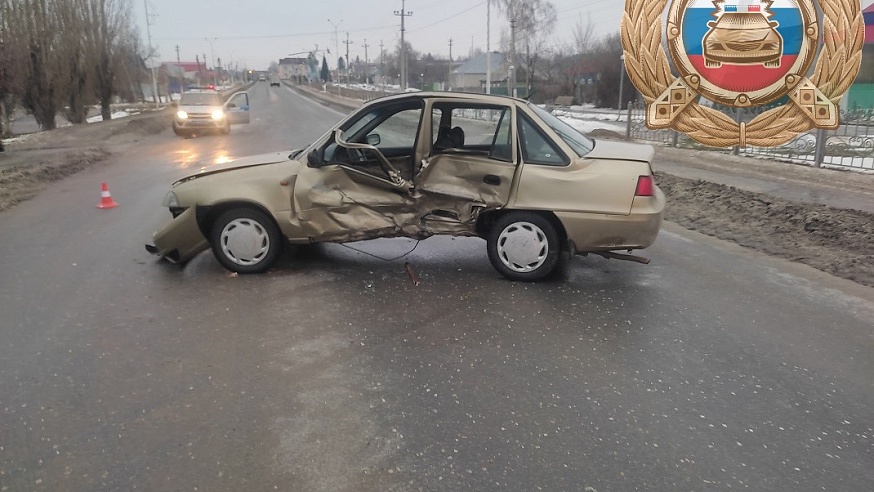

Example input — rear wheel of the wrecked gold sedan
[486,212,561,282]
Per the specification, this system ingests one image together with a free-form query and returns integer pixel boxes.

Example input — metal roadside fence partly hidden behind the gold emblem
[626,102,874,170]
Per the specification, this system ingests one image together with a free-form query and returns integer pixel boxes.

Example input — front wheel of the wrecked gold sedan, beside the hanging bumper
[209,208,283,273]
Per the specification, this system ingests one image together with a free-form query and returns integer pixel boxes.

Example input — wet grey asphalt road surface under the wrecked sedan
[0,84,874,492]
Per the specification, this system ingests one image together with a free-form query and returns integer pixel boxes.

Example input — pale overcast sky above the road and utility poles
[133,0,625,69]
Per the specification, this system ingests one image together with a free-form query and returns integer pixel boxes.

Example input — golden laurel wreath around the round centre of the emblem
[621,0,865,147]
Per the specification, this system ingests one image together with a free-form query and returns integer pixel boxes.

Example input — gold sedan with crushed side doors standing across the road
[146,92,665,281]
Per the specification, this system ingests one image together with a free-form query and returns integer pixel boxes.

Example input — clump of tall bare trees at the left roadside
[0,0,142,130]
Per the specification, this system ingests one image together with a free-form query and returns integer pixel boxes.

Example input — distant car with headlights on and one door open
[173,91,249,137]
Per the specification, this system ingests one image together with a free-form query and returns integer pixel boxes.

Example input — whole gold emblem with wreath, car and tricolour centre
[622,0,864,147]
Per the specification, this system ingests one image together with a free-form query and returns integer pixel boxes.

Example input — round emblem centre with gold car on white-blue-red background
[668,0,818,106]
